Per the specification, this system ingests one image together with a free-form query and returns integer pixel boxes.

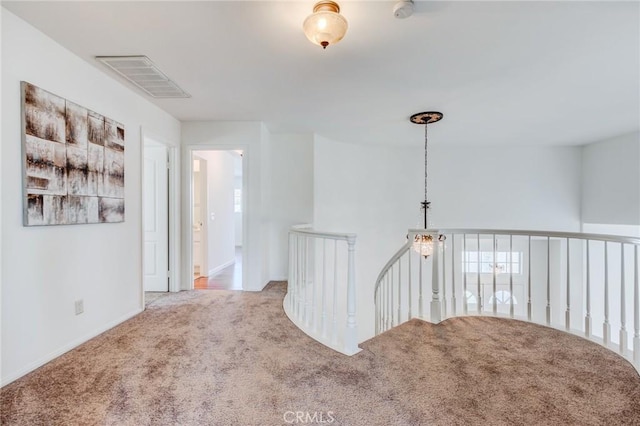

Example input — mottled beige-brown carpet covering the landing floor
[1,283,640,426]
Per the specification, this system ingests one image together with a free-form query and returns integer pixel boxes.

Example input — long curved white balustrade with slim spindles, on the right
[374,229,640,371]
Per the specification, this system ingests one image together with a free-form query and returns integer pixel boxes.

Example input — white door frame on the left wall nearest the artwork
[140,127,180,309]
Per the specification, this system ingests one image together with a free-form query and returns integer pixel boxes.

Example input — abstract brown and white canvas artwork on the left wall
[21,81,124,226]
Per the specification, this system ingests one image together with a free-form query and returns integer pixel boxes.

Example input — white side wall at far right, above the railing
[582,132,640,226]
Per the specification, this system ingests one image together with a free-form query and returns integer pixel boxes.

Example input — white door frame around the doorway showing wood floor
[182,144,250,290]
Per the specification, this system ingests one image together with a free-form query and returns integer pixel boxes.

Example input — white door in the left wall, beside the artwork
[143,143,169,291]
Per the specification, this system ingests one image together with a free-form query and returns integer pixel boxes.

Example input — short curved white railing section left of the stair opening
[283,226,360,355]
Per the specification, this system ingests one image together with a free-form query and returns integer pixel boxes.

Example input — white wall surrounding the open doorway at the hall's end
[182,121,268,291]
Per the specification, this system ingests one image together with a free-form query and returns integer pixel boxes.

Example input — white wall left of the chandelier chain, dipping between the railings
[313,136,423,340]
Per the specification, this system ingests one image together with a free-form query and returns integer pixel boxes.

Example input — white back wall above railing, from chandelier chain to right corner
[429,146,581,232]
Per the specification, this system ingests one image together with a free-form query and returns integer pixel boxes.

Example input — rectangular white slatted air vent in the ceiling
[96,56,191,98]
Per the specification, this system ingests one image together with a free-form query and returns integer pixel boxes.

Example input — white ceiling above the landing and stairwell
[3,0,640,145]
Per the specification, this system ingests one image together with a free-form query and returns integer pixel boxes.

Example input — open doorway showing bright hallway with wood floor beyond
[191,150,244,290]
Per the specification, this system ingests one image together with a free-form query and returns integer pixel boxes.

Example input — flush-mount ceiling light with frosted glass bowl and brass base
[302,0,349,49]
